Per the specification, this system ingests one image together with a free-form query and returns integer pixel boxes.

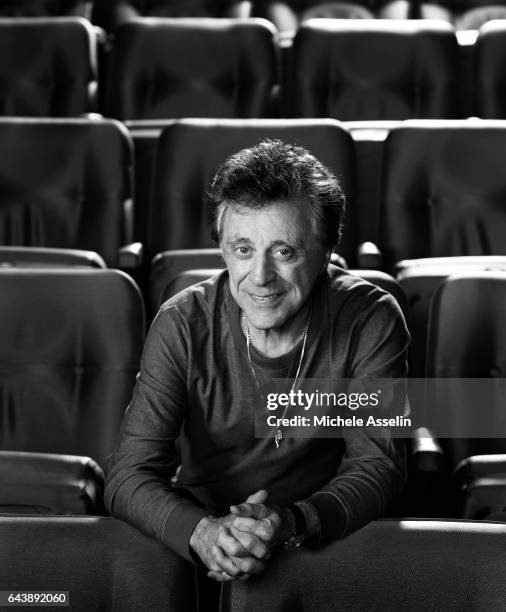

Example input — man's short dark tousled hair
[208,139,345,250]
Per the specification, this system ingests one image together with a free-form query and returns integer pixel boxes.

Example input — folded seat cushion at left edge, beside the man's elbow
[0,451,105,515]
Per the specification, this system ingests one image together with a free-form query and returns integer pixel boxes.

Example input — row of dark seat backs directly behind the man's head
[0,118,506,272]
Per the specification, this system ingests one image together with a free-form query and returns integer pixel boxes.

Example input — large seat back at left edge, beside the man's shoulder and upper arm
[0,268,144,467]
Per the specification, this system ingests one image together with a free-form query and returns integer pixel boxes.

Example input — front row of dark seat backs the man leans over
[0,516,506,612]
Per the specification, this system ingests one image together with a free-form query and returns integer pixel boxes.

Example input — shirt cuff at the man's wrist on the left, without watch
[161,500,209,565]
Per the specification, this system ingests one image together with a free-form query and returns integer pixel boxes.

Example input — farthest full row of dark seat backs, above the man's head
[5,18,506,121]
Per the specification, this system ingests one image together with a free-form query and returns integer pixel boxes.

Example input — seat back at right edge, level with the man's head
[380,121,506,270]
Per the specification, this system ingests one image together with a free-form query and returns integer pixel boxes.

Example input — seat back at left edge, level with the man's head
[0,118,132,266]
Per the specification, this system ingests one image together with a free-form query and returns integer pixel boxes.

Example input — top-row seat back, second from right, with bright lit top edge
[286,19,460,121]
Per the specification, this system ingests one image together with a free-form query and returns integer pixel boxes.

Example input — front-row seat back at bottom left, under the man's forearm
[0,516,196,612]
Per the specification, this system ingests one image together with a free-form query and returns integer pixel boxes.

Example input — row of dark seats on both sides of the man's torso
[0,260,506,518]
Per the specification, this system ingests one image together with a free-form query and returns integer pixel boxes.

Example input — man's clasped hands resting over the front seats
[190,490,284,582]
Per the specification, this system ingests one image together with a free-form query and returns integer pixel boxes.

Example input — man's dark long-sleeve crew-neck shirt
[105,266,409,561]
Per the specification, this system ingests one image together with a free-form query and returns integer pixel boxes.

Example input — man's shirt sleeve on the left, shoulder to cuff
[105,306,210,563]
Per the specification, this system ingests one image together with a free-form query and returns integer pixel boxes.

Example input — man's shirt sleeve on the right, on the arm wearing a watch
[297,292,409,544]
